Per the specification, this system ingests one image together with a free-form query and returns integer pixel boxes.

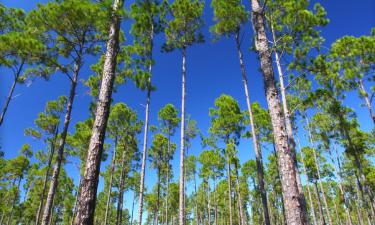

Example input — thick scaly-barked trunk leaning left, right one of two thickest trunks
[251,0,308,225]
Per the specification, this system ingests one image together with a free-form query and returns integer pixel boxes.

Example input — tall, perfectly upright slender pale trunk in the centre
[179,47,186,225]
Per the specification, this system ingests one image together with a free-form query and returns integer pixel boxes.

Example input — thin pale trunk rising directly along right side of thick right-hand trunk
[271,23,308,222]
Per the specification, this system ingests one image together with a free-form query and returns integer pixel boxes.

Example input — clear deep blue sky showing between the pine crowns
[0,0,375,221]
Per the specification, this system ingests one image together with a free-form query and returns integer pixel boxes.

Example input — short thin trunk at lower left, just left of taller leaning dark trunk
[35,125,59,224]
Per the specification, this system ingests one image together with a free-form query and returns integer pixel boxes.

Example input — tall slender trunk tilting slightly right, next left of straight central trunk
[138,26,154,225]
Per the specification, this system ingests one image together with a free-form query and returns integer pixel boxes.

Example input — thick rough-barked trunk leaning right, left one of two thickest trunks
[74,0,124,225]
